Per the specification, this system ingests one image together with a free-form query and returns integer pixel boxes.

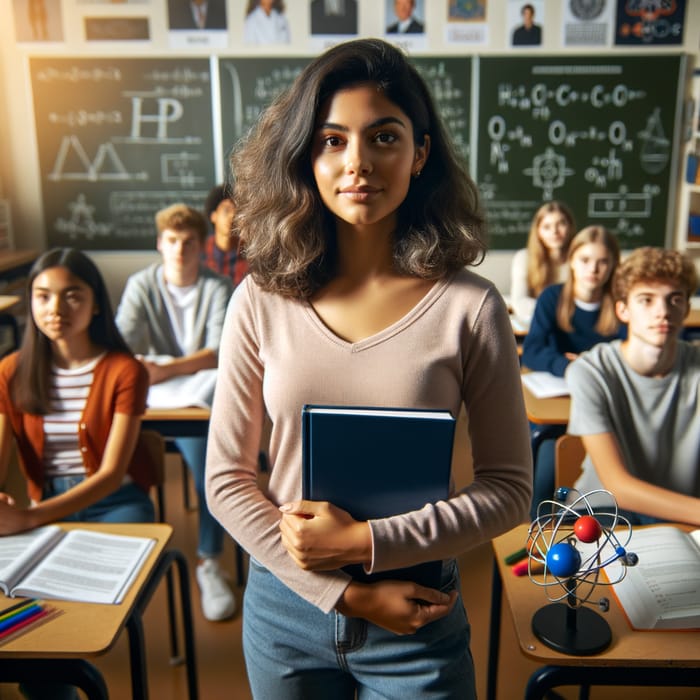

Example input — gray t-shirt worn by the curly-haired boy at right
[566,340,700,497]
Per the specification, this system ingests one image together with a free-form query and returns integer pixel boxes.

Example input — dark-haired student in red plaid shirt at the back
[202,185,248,287]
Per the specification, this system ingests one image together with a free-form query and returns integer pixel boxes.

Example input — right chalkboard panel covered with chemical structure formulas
[476,54,684,249]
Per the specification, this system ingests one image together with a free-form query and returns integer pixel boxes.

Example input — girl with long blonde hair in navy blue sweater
[522,226,620,518]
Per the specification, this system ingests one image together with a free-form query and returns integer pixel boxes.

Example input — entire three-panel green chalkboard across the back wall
[30,54,685,250]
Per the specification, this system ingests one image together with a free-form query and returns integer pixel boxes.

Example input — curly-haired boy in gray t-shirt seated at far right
[566,247,700,527]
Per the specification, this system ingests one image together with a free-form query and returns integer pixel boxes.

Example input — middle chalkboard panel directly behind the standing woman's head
[219,56,471,174]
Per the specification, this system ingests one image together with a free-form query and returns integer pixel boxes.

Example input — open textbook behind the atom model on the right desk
[606,525,700,630]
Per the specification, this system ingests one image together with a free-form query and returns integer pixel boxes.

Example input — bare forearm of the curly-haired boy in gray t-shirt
[582,433,700,527]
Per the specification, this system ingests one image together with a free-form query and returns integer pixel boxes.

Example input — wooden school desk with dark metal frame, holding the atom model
[486,525,700,700]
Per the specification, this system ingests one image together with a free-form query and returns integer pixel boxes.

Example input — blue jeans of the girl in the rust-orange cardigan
[43,475,155,523]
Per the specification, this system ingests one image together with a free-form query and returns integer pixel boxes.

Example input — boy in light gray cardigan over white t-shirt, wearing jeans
[116,204,235,620]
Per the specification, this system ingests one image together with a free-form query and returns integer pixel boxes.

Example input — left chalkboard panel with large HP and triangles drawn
[30,57,215,250]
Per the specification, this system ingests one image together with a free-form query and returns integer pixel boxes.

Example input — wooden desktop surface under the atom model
[492,525,700,668]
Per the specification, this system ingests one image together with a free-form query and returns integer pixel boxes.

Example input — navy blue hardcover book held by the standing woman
[302,405,455,588]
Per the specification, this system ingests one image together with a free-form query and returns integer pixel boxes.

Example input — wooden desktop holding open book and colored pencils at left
[0,523,172,659]
